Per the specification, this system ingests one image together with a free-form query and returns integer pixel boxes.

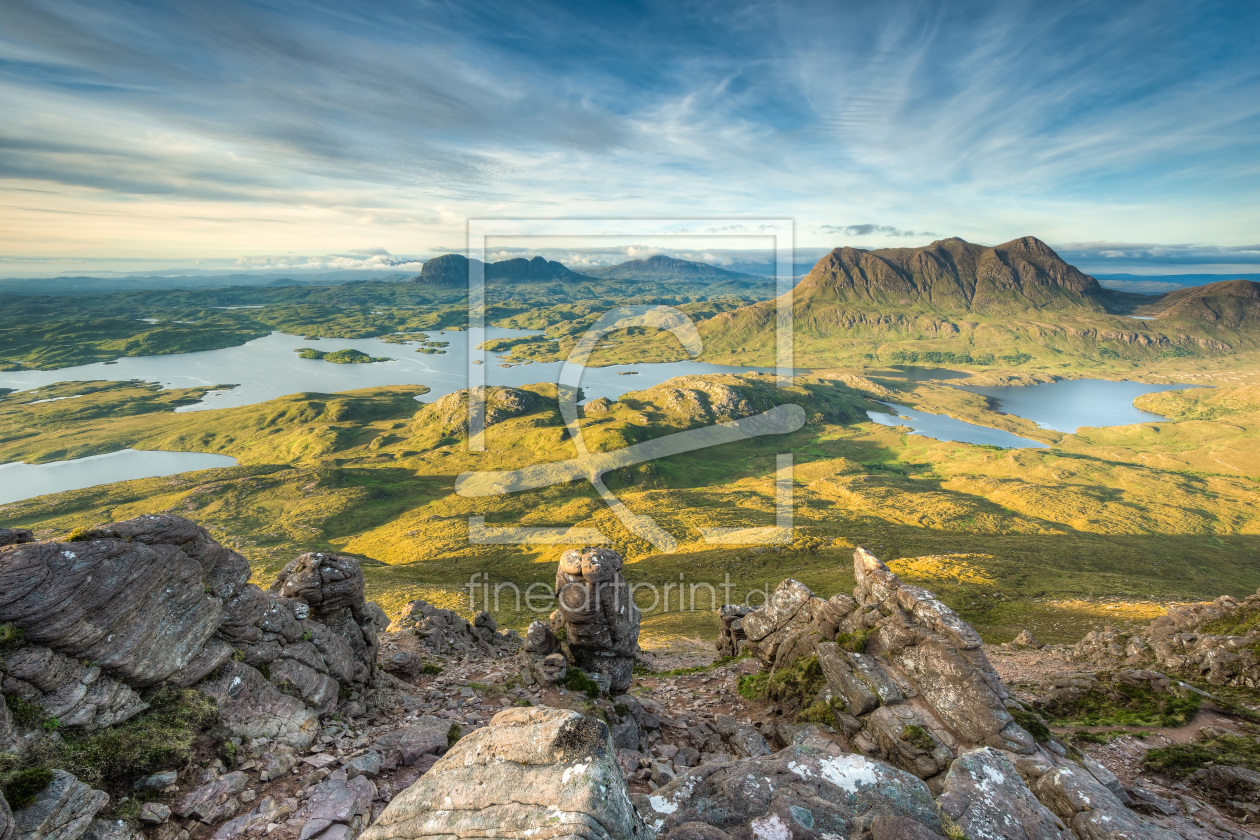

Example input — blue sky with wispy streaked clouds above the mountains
[0,0,1260,276]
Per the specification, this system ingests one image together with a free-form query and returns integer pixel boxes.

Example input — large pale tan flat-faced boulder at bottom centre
[363,708,651,840]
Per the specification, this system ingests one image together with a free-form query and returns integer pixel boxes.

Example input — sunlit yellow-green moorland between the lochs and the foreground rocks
[0,370,1260,644]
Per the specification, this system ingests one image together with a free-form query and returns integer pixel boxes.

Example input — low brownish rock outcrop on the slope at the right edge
[1067,592,1260,688]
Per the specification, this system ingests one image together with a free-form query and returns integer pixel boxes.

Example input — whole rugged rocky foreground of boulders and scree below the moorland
[0,526,1260,840]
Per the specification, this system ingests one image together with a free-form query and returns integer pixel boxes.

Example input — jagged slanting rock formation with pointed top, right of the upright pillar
[718,548,1034,791]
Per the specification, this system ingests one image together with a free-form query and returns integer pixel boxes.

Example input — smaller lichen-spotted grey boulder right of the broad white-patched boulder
[937,747,1074,840]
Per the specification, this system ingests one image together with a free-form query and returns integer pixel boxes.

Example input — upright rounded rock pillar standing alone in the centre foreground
[556,548,639,694]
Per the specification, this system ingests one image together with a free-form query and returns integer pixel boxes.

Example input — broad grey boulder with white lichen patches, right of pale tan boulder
[648,727,942,840]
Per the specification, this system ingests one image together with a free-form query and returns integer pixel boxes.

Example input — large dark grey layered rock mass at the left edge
[0,515,387,747]
